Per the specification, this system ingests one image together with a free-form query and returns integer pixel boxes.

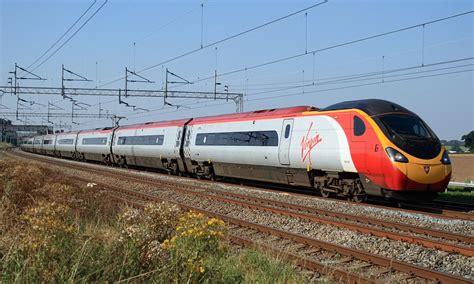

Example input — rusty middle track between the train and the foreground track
[66,161,474,256]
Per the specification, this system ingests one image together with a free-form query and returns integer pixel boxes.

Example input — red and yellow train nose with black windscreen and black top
[323,100,451,200]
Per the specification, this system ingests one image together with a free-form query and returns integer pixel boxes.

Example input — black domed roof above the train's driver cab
[321,99,415,116]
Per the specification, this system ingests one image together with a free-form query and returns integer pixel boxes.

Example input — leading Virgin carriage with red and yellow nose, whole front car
[184,100,451,201]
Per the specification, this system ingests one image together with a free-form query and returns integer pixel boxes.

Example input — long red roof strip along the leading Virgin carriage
[189,106,318,125]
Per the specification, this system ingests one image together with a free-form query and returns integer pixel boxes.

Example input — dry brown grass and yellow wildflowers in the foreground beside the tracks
[0,159,307,283]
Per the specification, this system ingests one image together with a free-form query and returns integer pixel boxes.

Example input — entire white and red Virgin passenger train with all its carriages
[21,99,452,202]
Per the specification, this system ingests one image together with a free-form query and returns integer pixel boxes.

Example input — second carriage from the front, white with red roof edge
[113,119,189,174]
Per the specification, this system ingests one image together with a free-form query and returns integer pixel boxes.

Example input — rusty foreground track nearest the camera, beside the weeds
[83,176,471,283]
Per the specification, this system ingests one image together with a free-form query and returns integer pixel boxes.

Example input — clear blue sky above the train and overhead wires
[0,0,474,140]
